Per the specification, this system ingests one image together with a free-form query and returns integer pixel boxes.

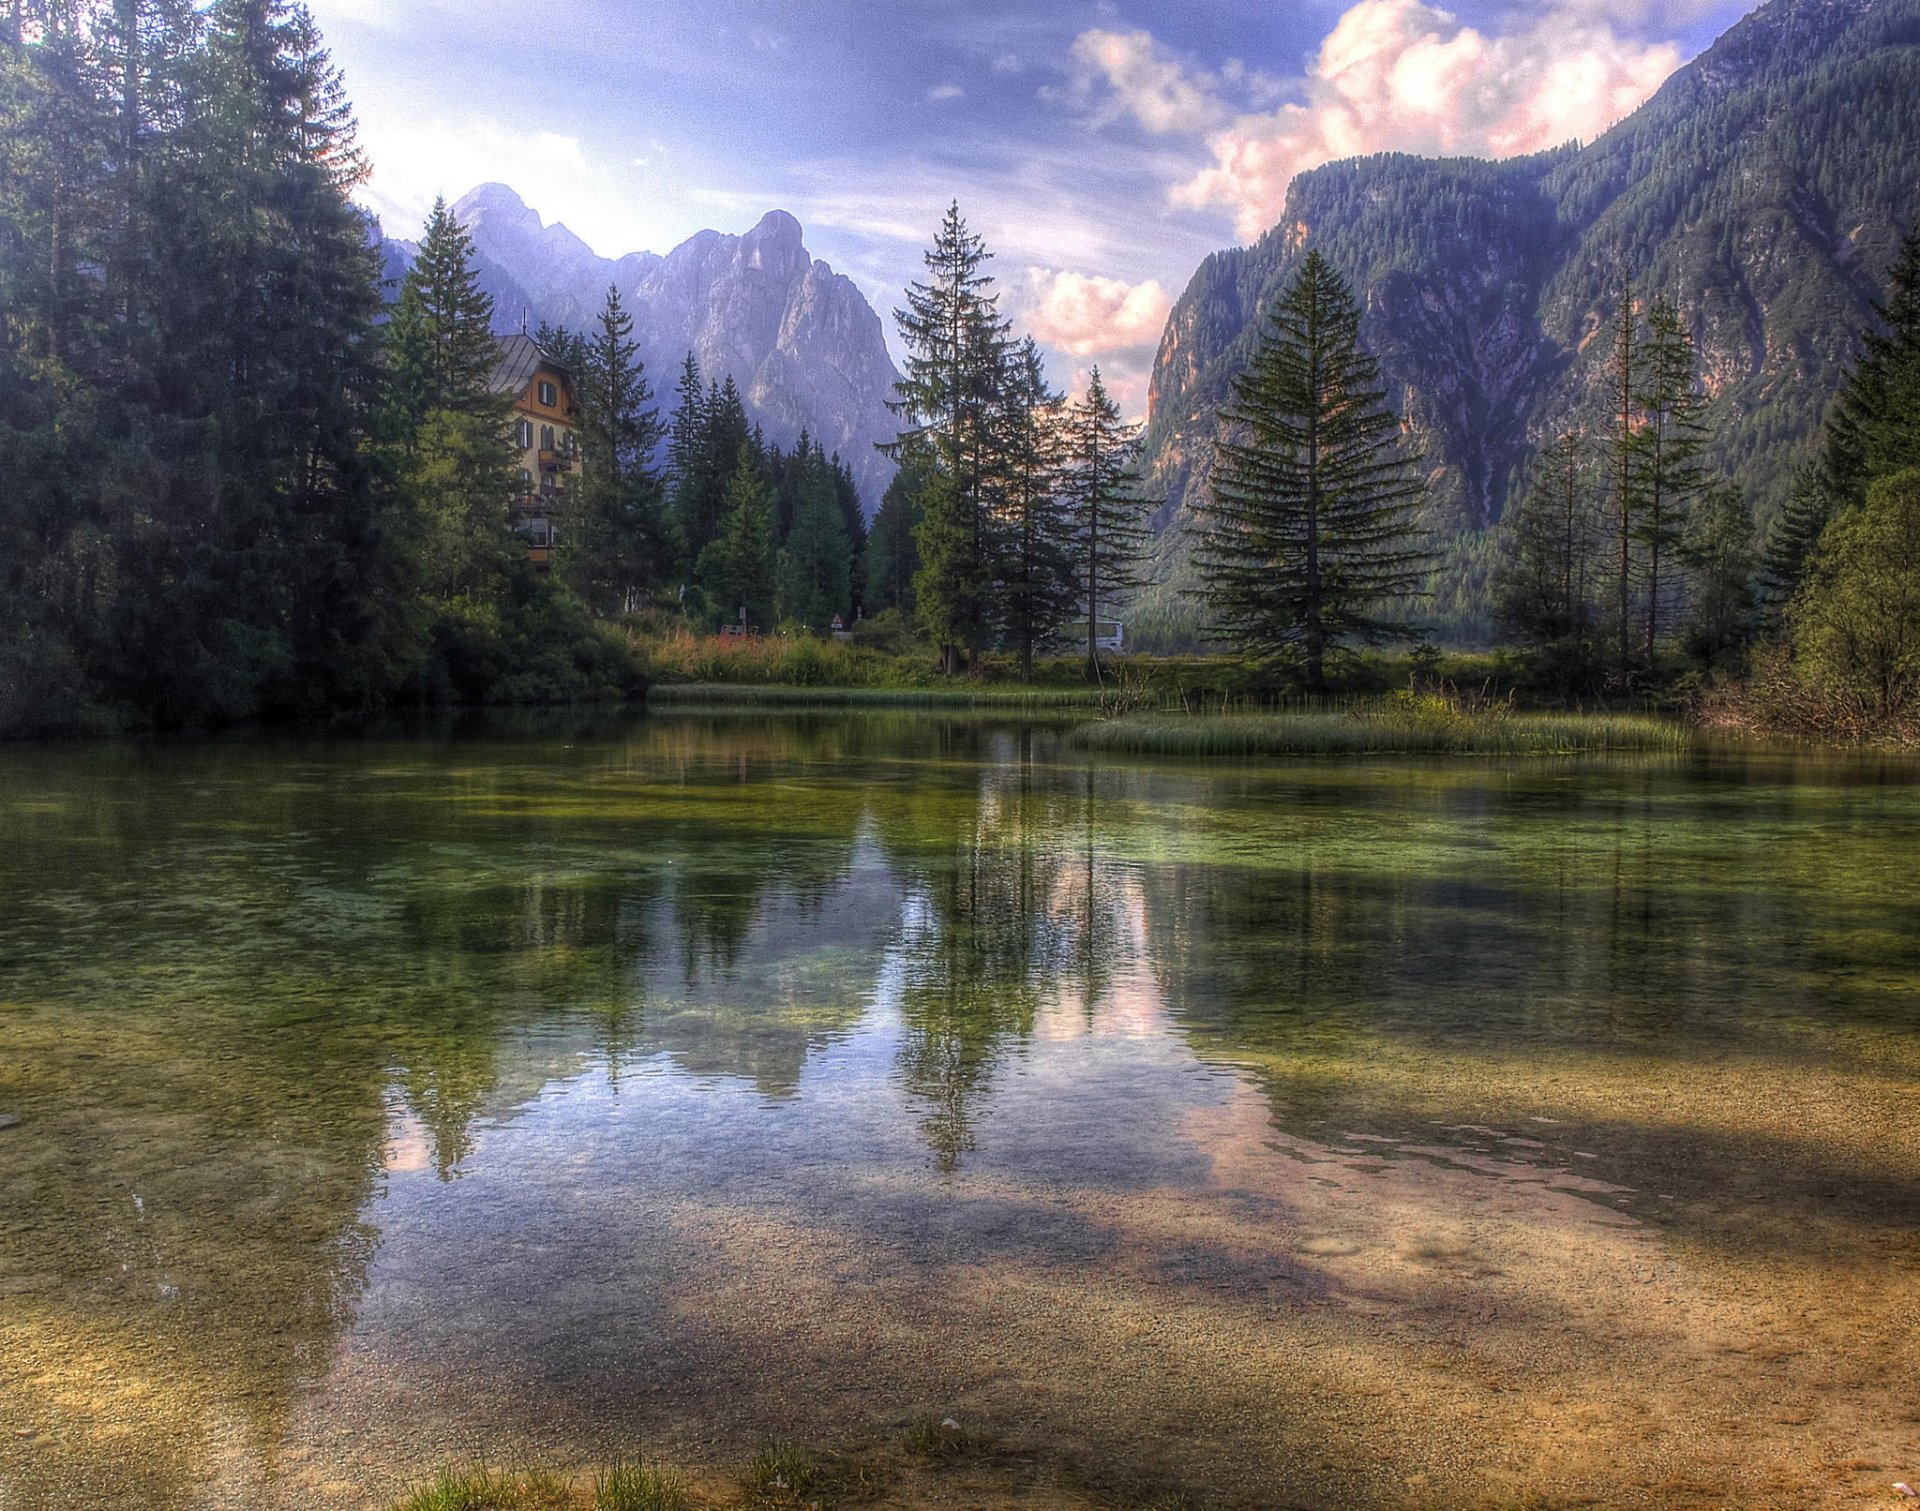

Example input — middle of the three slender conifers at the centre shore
[987,336,1079,682]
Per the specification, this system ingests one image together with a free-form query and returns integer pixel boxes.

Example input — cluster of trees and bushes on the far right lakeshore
[1492,236,1920,726]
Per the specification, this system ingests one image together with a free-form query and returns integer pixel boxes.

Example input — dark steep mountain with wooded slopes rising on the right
[1148,0,1920,622]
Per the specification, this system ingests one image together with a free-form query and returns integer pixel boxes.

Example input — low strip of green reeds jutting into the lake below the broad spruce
[1069,701,1690,760]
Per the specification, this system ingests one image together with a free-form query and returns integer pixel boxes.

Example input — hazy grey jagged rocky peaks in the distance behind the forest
[386,184,899,515]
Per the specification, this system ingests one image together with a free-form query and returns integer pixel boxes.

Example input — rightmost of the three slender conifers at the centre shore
[1060,367,1158,678]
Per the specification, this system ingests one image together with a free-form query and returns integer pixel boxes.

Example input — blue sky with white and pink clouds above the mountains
[309,0,1747,415]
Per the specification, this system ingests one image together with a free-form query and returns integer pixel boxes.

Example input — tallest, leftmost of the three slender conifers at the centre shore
[889,204,1010,674]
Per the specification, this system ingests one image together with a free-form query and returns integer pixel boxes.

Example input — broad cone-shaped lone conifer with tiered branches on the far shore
[1198,252,1430,691]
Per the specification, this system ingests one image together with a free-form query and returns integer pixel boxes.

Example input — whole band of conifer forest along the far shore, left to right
[0,0,1920,733]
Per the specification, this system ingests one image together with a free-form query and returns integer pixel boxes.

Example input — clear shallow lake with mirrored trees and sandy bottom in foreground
[0,714,1920,1511]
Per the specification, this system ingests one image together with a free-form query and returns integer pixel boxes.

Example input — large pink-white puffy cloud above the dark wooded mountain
[1173,0,1682,240]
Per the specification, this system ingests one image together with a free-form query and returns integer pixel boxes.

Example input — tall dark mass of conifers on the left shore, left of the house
[0,0,639,730]
